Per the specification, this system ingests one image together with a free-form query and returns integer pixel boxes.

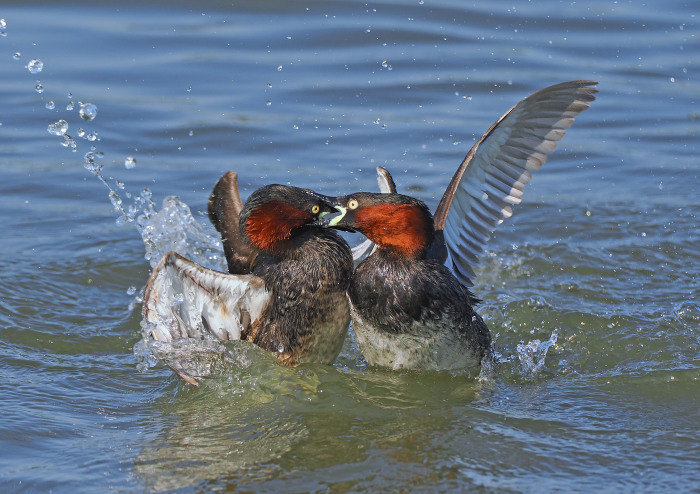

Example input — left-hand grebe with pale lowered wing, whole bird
[143,172,353,384]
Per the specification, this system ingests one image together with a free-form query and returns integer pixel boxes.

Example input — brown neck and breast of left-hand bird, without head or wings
[242,227,352,365]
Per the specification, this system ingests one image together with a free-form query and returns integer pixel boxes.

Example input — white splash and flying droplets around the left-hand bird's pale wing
[8,20,266,382]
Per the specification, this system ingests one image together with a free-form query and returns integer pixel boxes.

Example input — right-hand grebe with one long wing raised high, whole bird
[326,81,597,370]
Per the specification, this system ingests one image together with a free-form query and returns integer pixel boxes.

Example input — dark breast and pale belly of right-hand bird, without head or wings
[348,249,491,370]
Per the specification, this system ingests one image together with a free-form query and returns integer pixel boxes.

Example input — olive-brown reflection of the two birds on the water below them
[135,356,480,491]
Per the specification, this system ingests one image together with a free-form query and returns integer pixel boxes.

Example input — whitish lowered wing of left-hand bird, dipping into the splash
[143,252,270,384]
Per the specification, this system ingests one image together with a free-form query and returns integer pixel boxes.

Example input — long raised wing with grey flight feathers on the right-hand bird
[435,81,598,286]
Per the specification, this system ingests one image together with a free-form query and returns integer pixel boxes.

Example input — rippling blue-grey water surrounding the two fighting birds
[0,0,700,493]
